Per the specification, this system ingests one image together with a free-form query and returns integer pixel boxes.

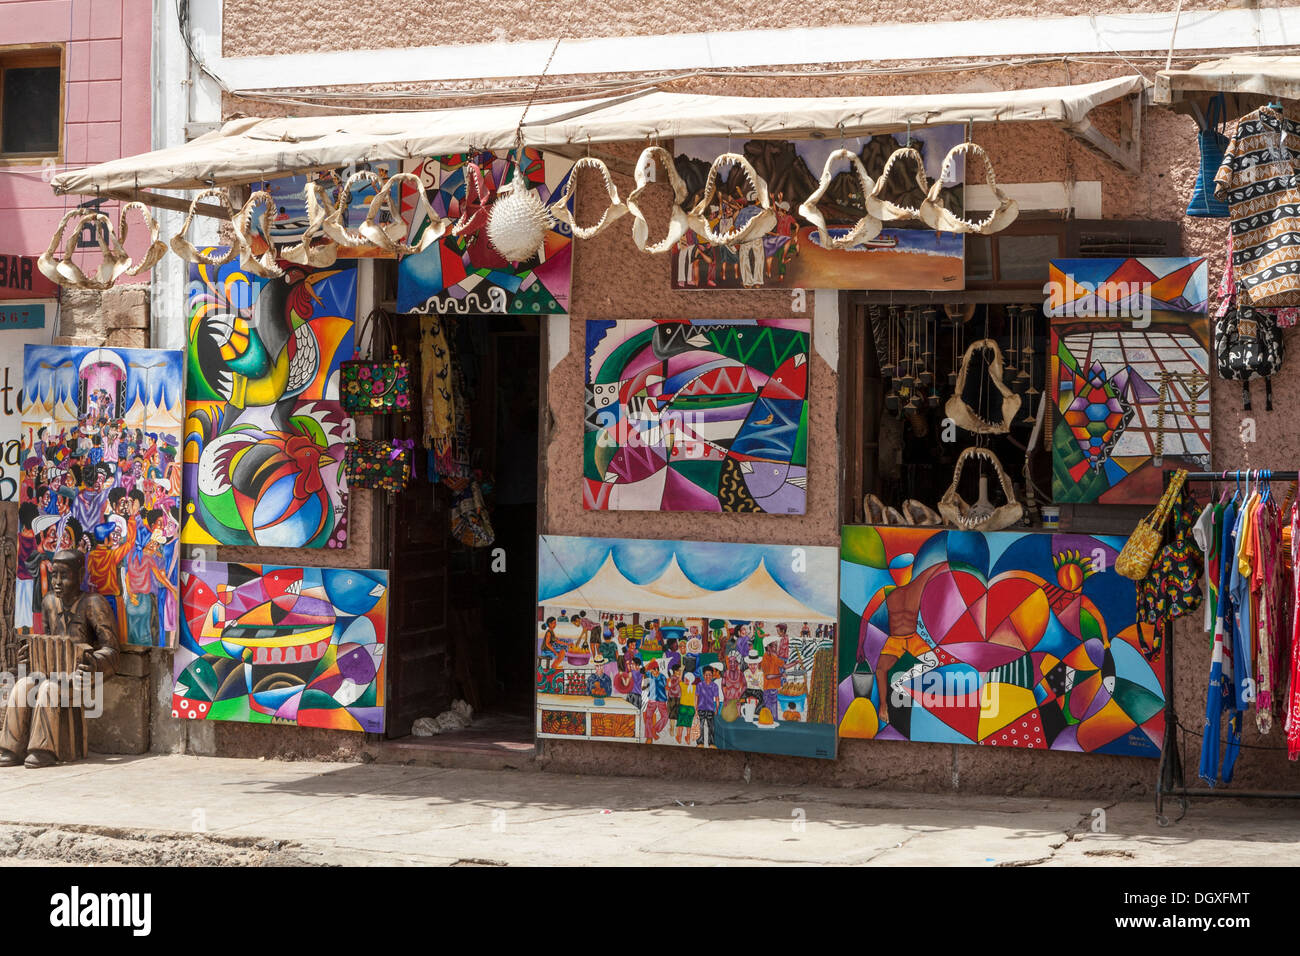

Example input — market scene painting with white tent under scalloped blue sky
[536,535,836,758]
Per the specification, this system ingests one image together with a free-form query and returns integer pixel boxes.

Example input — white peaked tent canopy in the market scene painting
[542,551,835,623]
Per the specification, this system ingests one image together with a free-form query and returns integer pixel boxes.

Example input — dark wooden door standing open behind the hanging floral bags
[376,316,452,737]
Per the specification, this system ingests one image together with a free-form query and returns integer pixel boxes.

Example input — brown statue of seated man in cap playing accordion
[0,550,118,767]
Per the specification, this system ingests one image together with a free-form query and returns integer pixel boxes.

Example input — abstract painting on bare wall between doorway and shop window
[582,319,809,515]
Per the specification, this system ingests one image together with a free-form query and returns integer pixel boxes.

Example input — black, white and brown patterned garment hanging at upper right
[1214,107,1300,307]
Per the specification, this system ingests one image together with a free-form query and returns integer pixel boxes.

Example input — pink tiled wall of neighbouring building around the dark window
[0,0,153,273]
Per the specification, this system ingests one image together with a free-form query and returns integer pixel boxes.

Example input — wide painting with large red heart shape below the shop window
[839,527,1165,757]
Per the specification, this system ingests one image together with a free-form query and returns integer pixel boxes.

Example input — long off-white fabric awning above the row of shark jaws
[53,75,1147,195]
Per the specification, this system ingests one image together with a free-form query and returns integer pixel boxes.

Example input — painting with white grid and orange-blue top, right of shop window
[1049,259,1210,505]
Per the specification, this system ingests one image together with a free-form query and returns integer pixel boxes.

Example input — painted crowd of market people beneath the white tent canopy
[537,609,835,747]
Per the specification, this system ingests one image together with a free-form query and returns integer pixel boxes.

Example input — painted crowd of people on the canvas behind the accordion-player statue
[14,400,181,645]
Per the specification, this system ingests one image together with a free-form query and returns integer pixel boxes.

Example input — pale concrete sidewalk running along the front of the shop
[0,756,1300,866]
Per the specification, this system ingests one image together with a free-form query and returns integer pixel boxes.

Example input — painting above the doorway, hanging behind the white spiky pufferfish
[398,148,573,316]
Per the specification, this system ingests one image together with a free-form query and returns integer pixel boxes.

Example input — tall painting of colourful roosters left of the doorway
[182,254,356,548]
